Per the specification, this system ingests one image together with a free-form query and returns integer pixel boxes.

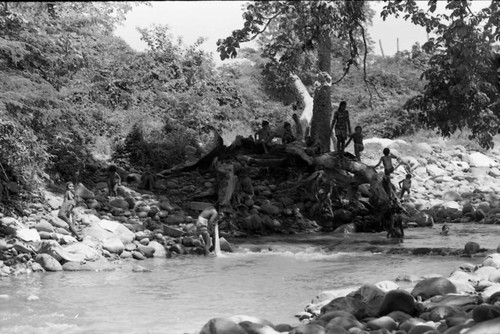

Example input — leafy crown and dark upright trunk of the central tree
[217,0,367,152]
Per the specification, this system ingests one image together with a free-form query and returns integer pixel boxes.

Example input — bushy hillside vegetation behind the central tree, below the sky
[0,2,498,211]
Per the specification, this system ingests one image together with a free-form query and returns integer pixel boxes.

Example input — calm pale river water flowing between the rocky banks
[0,224,500,334]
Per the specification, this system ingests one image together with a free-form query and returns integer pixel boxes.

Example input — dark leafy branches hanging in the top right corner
[381,0,500,148]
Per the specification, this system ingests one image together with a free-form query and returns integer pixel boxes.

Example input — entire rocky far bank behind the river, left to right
[0,134,500,275]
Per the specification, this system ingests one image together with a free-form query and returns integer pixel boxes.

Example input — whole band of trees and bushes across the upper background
[0,1,499,206]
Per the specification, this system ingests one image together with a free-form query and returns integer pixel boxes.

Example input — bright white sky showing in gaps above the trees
[115,0,489,63]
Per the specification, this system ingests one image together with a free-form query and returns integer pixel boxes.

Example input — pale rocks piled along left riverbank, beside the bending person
[0,167,242,276]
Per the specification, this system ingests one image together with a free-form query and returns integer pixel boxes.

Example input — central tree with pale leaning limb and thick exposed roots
[211,1,406,232]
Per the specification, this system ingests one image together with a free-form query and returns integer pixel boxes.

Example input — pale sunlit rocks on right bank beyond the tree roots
[348,138,500,231]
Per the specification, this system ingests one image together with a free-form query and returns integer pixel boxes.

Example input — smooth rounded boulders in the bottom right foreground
[197,253,500,334]
